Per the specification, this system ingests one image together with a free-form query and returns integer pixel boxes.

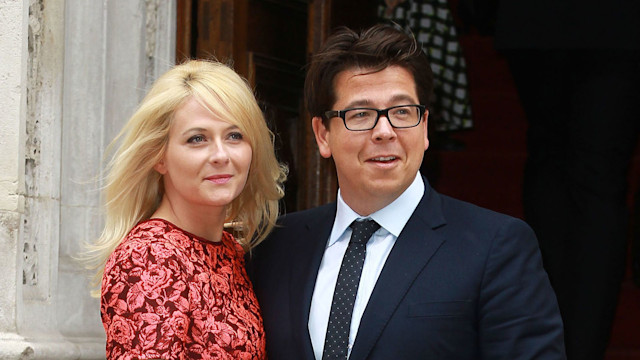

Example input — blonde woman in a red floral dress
[89,61,286,359]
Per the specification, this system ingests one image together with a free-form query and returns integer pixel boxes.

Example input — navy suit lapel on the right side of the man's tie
[349,183,445,360]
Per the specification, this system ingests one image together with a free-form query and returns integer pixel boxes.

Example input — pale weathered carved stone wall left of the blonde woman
[0,0,175,360]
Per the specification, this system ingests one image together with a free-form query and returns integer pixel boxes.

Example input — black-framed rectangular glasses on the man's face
[324,105,426,131]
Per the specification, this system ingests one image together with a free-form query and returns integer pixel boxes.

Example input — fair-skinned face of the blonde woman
[155,98,252,211]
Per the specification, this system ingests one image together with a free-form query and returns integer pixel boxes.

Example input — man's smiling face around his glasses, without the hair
[312,66,429,216]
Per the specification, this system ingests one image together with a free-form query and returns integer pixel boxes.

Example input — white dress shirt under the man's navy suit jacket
[308,172,424,359]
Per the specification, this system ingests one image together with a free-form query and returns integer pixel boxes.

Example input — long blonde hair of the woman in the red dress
[84,60,287,284]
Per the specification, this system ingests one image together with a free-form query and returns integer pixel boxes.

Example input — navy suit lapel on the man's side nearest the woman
[289,203,336,360]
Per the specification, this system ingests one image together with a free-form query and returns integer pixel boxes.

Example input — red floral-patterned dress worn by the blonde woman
[100,219,266,360]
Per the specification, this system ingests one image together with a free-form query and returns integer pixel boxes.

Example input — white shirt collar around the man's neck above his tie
[327,172,424,246]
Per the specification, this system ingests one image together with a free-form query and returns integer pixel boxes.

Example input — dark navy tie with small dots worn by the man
[322,220,380,360]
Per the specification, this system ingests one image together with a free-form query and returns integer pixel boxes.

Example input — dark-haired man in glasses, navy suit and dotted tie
[251,25,564,360]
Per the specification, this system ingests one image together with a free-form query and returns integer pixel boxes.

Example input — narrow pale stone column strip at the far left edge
[0,0,29,359]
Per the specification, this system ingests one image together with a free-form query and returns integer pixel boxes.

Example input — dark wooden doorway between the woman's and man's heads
[176,0,377,212]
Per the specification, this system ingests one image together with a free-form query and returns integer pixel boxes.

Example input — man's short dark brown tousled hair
[304,24,433,121]
